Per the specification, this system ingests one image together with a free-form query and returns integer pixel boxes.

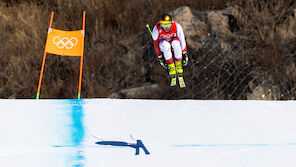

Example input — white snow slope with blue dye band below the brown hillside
[0,99,296,167]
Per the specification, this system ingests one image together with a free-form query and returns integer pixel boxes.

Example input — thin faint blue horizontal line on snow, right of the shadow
[172,143,296,147]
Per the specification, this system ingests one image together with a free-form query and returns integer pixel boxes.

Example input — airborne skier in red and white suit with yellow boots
[152,14,188,88]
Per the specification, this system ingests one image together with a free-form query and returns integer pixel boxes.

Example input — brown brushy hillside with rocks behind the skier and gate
[0,0,296,100]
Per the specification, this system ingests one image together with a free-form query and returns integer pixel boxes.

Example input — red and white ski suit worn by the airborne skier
[152,21,187,64]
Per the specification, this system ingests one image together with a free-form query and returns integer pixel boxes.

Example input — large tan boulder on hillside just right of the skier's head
[171,7,238,50]
